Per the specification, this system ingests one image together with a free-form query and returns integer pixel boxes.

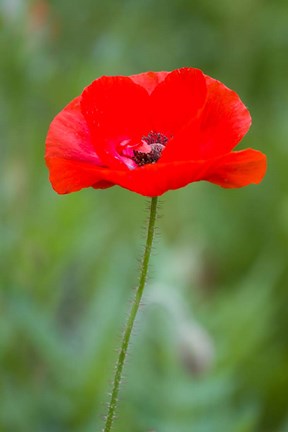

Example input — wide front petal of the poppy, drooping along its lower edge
[47,149,266,197]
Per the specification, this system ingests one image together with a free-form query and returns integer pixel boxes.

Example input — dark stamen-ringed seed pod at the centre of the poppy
[132,131,168,166]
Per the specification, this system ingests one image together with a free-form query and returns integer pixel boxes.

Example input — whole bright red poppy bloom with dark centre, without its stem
[45,68,266,197]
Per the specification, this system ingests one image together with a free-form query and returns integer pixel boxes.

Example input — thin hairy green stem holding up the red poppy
[103,197,157,432]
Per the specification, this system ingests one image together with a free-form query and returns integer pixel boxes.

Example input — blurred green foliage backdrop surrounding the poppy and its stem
[0,0,288,432]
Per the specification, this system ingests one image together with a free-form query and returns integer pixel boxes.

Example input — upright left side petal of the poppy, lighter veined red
[45,97,102,165]
